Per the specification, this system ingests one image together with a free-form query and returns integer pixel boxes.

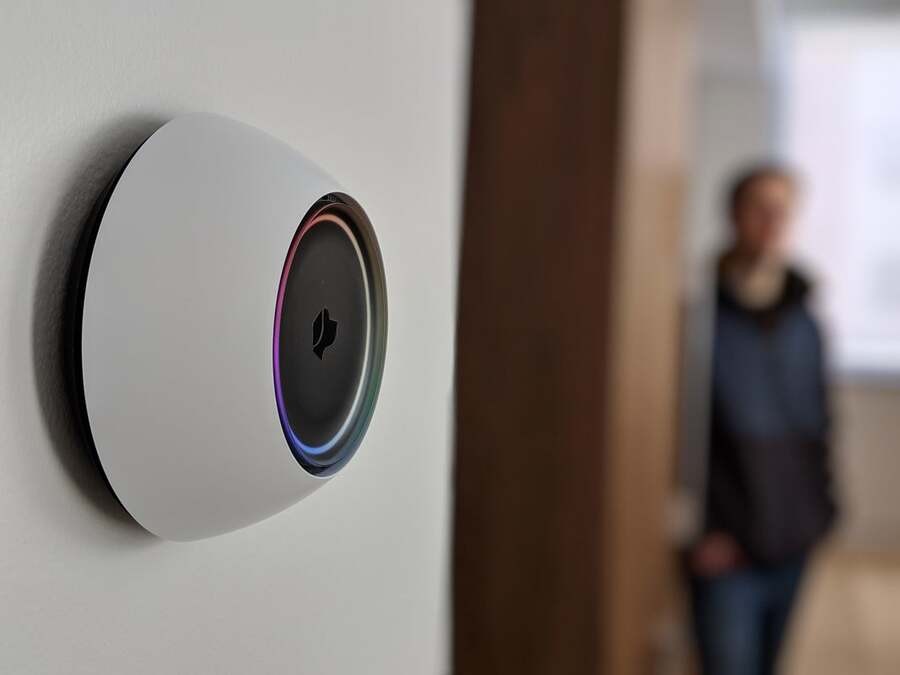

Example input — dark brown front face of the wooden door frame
[453,0,621,675]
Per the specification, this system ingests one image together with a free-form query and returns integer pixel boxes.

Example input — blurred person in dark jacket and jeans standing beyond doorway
[688,165,835,675]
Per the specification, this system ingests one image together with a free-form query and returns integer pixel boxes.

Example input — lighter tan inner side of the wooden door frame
[601,0,694,675]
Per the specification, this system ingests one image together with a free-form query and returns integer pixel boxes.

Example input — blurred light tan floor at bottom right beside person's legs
[784,550,900,675]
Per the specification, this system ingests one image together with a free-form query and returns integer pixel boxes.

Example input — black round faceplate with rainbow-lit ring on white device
[273,196,385,476]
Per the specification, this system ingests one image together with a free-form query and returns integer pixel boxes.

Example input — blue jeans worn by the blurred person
[691,559,806,675]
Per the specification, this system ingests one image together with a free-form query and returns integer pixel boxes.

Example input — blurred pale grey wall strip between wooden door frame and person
[673,0,779,538]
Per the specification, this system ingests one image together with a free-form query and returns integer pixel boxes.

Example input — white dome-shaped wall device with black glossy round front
[69,114,387,540]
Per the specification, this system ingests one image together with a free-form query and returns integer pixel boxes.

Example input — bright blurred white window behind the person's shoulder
[783,19,900,376]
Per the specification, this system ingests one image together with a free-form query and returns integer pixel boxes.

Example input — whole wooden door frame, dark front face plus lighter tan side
[452,0,692,675]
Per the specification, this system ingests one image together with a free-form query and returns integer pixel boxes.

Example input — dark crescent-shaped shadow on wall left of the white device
[31,115,165,537]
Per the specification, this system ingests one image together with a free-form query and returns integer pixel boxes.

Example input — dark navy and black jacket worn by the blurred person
[706,270,835,563]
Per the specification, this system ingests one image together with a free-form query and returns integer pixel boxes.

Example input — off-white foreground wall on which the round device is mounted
[0,0,468,675]
